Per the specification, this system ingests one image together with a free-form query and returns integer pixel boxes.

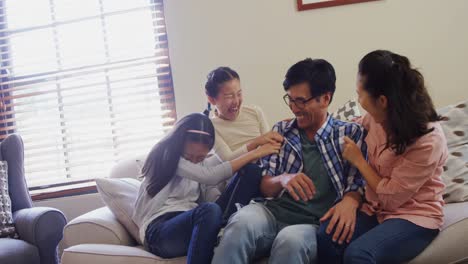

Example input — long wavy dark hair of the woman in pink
[359,50,441,155]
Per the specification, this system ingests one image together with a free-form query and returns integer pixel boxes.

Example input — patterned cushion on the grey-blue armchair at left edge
[0,160,17,237]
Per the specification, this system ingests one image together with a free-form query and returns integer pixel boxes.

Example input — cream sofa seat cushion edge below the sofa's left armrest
[62,244,187,264]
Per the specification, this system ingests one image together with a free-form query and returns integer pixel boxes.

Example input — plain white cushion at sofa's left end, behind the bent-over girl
[96,178,142,244]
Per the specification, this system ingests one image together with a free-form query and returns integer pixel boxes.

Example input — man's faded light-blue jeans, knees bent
[212,203,318,264]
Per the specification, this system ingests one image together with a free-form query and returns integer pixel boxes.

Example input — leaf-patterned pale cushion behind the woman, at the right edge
[438,101,468,203]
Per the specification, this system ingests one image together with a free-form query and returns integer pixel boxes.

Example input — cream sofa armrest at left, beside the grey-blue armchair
[63,206,136,248]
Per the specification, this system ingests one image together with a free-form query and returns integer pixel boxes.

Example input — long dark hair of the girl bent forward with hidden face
[142,113,215,197]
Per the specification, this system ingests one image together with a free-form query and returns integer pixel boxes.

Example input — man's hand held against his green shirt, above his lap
[281,173,315,202]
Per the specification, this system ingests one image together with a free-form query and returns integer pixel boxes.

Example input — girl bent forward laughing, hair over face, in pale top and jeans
[133,113,280,263]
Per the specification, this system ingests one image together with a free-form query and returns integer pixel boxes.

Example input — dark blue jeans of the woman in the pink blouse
[317,212,439,264]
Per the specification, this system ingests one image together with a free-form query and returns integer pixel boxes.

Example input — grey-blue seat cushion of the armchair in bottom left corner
[0,238,39,264]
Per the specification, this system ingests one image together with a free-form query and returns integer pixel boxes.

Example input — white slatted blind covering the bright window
[0,0,176,189]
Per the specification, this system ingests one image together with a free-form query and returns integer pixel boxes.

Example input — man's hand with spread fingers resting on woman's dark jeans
[320,196,359,245]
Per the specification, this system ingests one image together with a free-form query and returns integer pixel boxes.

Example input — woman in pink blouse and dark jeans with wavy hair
[318,50,448,264]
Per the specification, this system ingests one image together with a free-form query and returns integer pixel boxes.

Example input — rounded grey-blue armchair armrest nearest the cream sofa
[13,207,67,263]
